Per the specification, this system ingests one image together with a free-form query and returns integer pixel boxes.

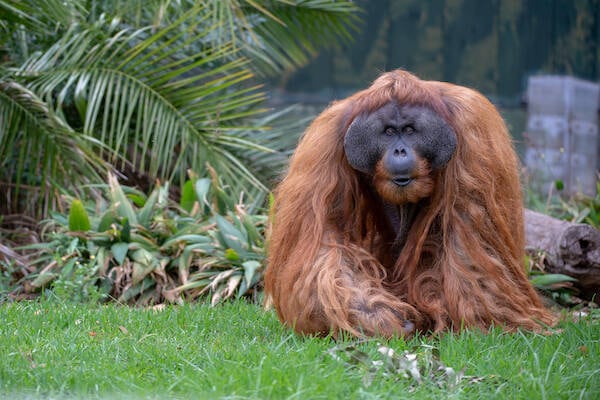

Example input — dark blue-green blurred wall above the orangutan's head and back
[282,0,600,103]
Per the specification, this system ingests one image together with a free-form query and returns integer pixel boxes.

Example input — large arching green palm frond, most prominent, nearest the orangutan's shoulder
[16,8,266,196]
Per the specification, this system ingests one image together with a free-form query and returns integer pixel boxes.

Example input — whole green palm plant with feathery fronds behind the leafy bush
[0,0,356,216]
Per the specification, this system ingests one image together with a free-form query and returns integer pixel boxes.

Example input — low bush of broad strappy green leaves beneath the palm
[23,170,267,305]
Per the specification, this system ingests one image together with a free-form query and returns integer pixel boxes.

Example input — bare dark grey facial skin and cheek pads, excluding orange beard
[344,102,456,187]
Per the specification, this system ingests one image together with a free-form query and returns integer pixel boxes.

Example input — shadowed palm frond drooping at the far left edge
[0,80,108,216]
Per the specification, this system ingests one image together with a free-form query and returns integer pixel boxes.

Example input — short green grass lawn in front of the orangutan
[0,300,600,399]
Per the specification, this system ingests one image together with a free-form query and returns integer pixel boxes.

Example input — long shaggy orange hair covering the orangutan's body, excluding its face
[265,70,554,335]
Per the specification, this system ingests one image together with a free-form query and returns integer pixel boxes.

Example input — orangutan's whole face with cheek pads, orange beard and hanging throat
[344,102,457,255]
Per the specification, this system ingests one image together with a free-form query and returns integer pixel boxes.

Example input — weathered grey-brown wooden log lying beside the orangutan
[525,210,600,302]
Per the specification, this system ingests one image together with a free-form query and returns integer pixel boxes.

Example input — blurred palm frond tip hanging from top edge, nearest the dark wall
[205,0,359,74]
